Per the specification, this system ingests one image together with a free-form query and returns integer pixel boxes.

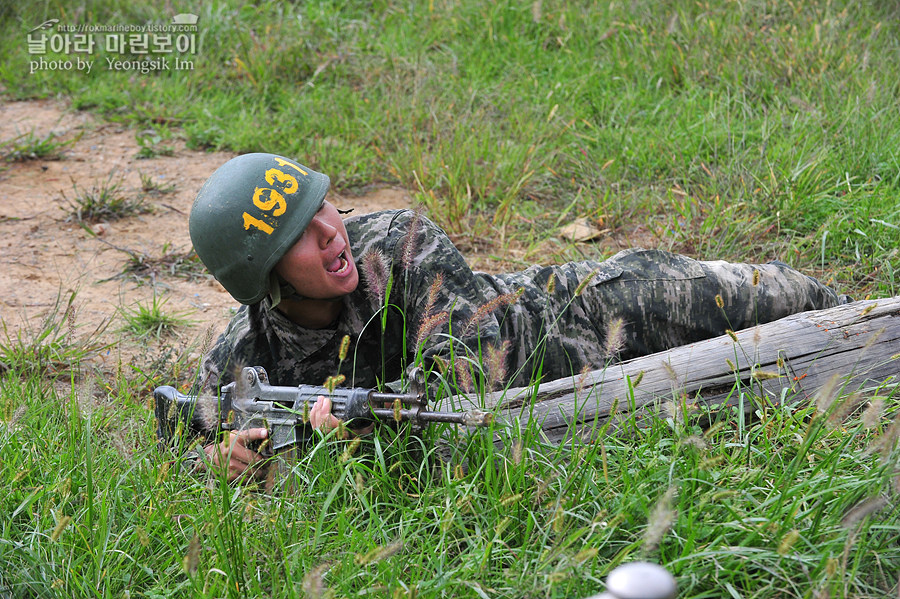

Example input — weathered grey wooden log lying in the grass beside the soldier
[438,297,900,442]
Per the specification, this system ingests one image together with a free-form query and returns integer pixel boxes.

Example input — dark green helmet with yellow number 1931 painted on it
[189,154,330,304]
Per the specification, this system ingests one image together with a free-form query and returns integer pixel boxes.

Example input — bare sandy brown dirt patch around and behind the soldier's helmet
[0,100,412,370]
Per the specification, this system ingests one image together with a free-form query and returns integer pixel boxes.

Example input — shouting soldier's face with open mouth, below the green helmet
[275,202,359,299]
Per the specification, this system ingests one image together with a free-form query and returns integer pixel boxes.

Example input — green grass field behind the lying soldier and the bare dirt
[0,0,900,295]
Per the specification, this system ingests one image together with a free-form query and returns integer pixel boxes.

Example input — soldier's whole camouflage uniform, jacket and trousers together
[201,211,840,390]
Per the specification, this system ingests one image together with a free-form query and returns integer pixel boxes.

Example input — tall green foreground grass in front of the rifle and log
[0,356,900,598]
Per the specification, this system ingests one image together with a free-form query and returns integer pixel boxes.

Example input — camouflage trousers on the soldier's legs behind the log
[580,250,846,360]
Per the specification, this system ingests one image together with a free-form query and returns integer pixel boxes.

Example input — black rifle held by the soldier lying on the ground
[153,366,493,453]
